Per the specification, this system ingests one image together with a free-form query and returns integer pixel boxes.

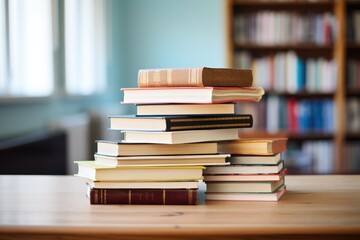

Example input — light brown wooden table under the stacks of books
[0,175,360,239]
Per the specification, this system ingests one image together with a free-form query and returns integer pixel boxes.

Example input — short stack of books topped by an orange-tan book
[204,138,287,201]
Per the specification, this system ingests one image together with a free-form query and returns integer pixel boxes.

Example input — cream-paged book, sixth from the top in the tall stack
[96,140,217,156]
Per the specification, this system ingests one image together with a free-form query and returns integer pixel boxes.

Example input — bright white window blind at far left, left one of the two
[0,0,54,96]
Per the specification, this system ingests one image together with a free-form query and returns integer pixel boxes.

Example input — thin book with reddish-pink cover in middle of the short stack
[204,168,287,182]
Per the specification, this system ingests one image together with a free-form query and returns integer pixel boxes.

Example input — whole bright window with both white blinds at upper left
[0,0,107,97]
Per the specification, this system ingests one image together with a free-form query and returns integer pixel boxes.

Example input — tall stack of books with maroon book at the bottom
[77,67,264,204]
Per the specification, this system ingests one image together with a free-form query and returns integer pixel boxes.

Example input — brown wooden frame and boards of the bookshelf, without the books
[227,0,348,173]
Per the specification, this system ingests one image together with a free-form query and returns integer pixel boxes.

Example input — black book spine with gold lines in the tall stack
[165,114,253,131]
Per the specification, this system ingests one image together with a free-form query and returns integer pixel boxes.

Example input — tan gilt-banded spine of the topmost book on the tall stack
[138,68,204,88]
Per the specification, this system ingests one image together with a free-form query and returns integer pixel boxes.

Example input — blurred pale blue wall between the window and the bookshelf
[0,0,226,138]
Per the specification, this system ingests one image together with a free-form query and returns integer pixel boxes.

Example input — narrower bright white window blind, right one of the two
[64,0,106,95]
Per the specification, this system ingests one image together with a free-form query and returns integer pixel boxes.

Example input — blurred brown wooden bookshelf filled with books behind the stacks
[227,0,360,174]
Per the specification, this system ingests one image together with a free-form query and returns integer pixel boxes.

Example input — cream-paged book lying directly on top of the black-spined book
[136,103,236,116]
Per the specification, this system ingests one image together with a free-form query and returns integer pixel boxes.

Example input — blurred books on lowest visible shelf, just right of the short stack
[284,140,335,174]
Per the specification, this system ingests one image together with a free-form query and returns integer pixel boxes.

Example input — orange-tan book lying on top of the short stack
[218,138,287,155]
